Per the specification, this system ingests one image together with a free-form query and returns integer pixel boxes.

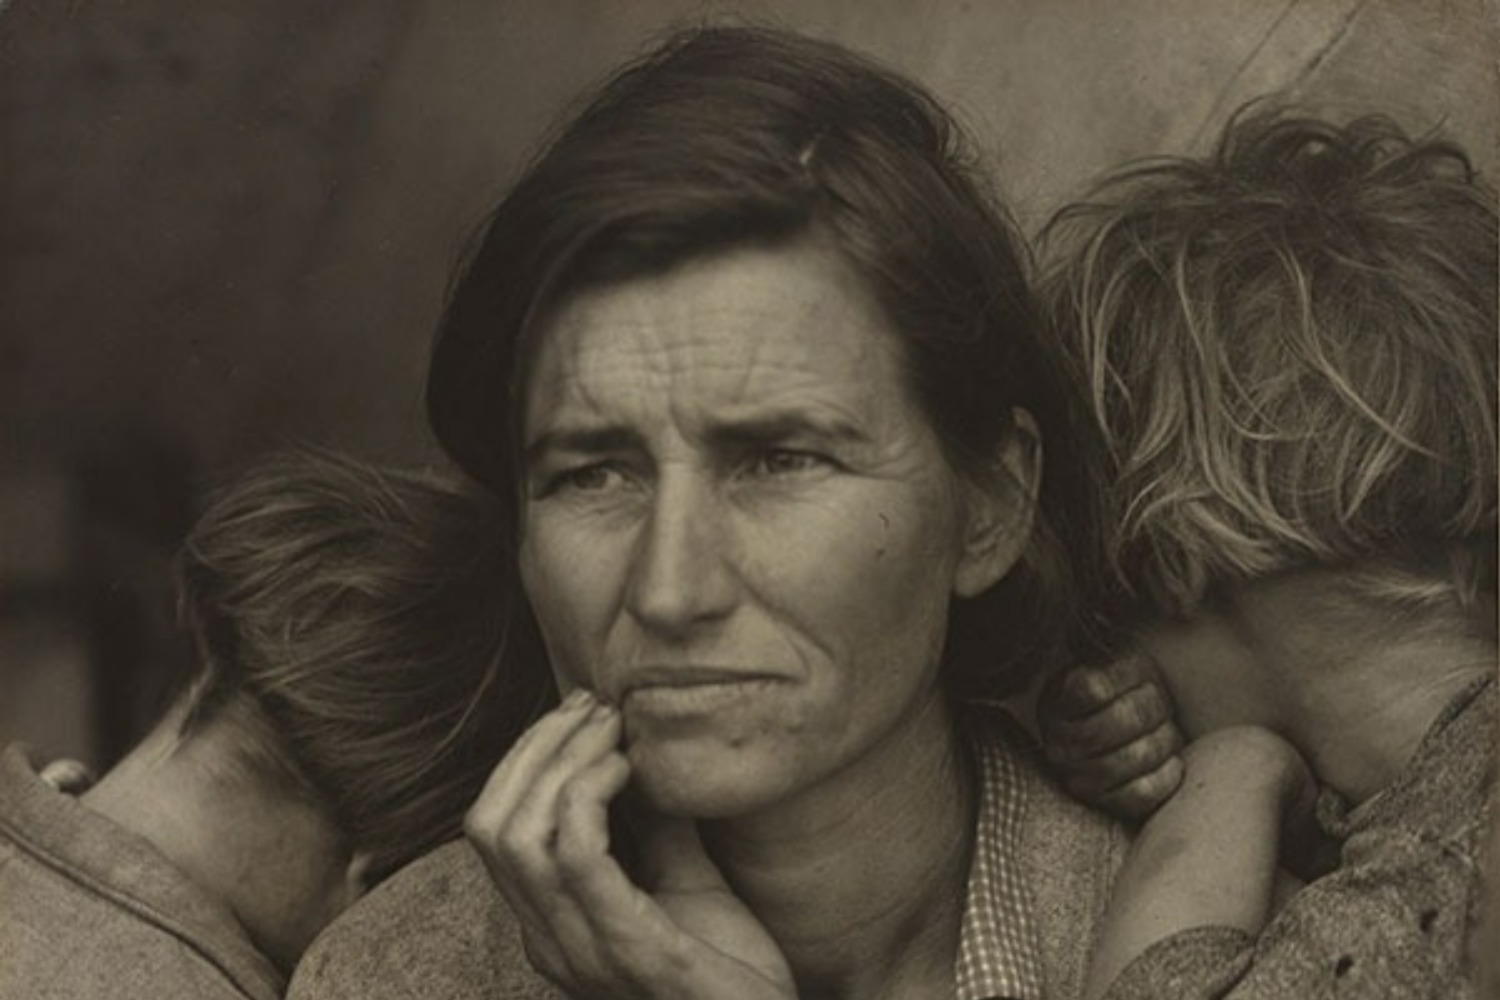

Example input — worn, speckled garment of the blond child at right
[1106,678,1497,1000]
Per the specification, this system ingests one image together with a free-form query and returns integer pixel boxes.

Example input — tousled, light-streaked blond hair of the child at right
[1044,109,1497,613]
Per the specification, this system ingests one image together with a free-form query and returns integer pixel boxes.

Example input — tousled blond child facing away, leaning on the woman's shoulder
[1041,112,1497,1000]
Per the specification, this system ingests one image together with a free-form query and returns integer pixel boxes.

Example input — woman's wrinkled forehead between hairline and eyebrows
[527,243,905,434]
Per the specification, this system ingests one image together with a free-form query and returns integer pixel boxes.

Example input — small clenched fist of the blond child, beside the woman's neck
[1037,654,1182,820]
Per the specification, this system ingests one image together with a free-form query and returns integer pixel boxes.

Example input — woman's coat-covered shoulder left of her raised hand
[287,841,561,1000]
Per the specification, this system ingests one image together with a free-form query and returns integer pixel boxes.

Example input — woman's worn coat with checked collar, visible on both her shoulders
[288,714,1127,1000]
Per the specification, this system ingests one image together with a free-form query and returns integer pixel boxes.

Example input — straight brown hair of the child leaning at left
[177,453,551,879]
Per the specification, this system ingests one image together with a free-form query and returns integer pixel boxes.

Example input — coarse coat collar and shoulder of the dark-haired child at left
[0,747,285,1000]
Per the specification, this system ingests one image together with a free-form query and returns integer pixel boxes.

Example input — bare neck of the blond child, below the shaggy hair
[1145,570,1496,802]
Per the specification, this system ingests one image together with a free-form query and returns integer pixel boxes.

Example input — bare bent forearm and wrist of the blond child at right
[1086,726,1316,1000]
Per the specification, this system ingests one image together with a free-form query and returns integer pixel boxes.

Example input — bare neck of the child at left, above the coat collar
[81,718,359,973]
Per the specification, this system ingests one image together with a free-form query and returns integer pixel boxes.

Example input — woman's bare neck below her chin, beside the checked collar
[704,694,977,1000]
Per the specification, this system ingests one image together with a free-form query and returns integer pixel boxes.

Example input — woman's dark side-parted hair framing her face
[428,27,1092,700]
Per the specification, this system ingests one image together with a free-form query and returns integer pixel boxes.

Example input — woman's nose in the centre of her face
[626,477,735,633]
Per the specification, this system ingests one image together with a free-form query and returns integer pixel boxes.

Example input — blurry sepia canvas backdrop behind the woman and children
[0,0,1500,766]
